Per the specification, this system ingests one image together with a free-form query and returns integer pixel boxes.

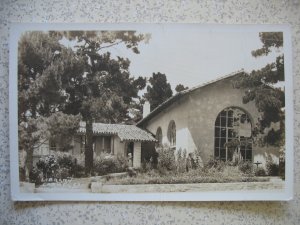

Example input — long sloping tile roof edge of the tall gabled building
[137,69,246,127]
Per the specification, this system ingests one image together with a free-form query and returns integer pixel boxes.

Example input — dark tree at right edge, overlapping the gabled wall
[235,32,285,146]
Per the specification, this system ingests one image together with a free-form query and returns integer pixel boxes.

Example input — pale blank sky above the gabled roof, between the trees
[62,25,280,91]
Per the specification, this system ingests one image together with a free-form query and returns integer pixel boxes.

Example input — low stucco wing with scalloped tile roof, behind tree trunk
[33,122,156,168]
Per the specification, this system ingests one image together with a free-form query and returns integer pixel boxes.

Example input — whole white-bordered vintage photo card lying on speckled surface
[10,24,293,201]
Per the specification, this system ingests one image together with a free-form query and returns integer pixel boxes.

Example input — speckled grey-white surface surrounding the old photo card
[0,0,300,225]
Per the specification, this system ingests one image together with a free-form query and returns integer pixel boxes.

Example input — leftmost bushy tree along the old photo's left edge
[18,31,80,177]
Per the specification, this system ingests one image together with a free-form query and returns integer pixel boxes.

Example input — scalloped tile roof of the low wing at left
[78,122,156,142]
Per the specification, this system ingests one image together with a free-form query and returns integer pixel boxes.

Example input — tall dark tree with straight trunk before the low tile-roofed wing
[51,31,147,174]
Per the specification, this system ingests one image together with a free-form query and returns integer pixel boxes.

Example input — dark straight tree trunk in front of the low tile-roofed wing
[84,120,94,176]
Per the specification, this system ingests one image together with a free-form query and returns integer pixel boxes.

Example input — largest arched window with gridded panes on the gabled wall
[215,107,252,161]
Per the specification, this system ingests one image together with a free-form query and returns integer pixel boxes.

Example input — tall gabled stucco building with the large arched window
[137,71,279,166]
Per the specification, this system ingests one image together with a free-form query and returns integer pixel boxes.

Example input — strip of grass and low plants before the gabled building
[105,167,269,185]
